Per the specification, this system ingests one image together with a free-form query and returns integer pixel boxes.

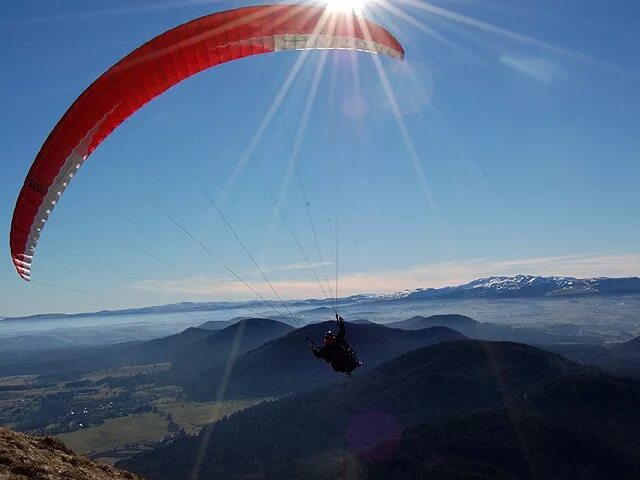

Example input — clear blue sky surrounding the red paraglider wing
[0,0,640,316]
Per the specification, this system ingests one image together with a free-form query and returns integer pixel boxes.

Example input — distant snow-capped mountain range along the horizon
[2,275,640,321]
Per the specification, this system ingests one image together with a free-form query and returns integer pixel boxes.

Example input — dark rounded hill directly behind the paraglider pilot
[178,322,465,400]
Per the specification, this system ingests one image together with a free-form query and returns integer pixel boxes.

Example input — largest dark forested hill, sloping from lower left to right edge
[121,341,640,480]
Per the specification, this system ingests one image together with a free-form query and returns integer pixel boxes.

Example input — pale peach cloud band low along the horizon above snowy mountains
[133,254,640,300]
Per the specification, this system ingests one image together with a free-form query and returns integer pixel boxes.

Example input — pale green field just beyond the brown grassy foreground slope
[57,413,169,454]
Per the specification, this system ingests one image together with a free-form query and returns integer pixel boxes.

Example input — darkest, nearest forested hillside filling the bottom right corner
[367,376,640,480]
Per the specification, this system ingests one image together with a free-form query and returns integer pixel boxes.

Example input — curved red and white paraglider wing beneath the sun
[10,5,404,280]
